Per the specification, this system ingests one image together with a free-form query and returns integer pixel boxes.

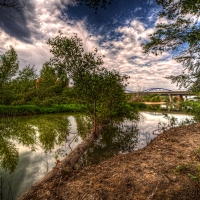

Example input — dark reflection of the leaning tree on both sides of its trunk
[75,116,139,166]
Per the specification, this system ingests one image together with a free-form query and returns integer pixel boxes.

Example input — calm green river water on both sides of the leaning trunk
[0,112,192,200]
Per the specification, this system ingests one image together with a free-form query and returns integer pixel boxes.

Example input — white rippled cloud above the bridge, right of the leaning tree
[99,20,182,90]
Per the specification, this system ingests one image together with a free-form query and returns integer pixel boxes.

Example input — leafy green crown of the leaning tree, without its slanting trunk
[47,32,138,130]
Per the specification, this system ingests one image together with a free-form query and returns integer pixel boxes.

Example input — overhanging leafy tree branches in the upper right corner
[143,0,200,91]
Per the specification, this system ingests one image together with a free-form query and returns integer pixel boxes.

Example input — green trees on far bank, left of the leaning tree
[0,47,72,106]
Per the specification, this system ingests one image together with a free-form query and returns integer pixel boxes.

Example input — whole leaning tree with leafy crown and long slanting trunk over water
[20,32,138,200]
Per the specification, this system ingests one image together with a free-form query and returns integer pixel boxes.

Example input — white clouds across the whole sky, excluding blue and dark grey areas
[0,0,182,89]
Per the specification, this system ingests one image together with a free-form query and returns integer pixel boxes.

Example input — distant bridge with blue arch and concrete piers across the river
[125,88,195,102]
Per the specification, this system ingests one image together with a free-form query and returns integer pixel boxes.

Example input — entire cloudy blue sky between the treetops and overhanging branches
[0,0,182,91]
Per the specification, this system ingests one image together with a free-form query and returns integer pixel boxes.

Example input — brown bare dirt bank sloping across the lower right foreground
[28,123,200,200]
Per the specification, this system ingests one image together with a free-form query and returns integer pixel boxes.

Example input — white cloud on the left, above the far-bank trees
[0,0,97,71]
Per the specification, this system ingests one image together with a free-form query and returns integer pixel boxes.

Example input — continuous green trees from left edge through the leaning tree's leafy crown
[0,32,138,127]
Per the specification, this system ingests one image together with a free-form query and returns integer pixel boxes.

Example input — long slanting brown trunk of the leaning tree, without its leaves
[18,126,103,200]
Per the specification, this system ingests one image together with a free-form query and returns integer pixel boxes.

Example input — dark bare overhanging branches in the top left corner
[0,0,25,11]
